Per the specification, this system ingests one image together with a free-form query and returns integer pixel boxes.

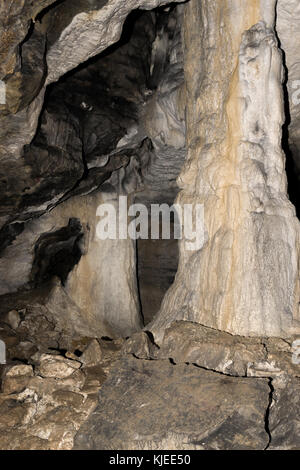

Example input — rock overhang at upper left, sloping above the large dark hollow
[0,0,183,227]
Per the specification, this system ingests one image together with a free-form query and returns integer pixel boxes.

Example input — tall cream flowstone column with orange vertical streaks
[150,0,300,340]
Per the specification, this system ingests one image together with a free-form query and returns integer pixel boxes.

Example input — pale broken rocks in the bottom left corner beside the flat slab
[0,358,95,450]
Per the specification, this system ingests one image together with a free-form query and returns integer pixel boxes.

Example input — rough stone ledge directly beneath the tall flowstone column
[151,321,300,378]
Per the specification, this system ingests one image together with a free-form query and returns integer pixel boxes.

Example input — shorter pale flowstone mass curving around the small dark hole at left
[0,193,142,337]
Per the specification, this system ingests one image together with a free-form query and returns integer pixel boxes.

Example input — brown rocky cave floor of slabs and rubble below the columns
[0,310,300,450]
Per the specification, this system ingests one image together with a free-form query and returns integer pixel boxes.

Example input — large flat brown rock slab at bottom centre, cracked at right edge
[74,357,270,450]
